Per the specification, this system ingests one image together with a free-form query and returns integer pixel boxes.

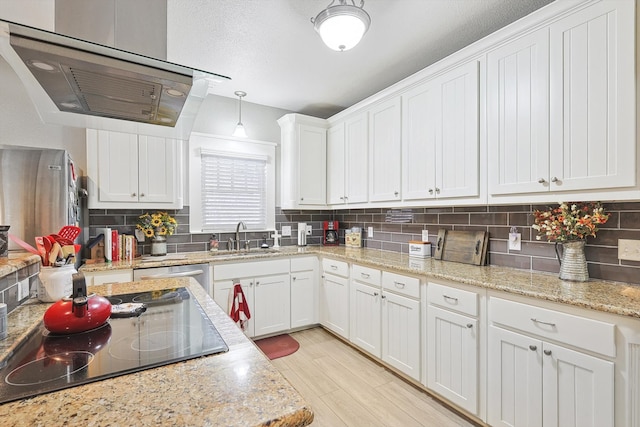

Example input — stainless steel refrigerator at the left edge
[0,146,82,250]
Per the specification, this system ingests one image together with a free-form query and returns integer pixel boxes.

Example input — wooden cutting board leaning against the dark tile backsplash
[434,230,489,265]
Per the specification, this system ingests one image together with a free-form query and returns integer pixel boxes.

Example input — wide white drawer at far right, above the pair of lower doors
[489,298,616,357]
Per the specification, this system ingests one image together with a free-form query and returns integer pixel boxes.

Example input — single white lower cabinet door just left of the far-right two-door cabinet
[427,305,478,414]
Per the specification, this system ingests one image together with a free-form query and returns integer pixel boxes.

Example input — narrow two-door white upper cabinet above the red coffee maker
[327,112,369,205]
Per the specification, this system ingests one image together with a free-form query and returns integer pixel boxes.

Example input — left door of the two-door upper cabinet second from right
[402,84,437,200]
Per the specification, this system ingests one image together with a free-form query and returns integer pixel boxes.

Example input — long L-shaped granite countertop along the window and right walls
[80,246,640,318]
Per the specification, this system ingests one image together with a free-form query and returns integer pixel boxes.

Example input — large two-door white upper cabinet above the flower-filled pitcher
[487,0,636,195]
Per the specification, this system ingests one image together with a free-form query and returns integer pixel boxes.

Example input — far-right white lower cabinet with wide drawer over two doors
[487,298,615,427]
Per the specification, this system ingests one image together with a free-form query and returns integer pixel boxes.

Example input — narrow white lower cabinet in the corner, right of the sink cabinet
[291,257,318,329]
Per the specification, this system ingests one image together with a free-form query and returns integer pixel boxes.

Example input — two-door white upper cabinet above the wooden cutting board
[402,61,480,200]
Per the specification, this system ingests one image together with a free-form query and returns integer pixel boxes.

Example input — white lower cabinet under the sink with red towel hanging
[213,259,291,337]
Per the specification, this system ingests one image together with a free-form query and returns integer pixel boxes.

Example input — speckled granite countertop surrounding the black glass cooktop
[0,278,313,426]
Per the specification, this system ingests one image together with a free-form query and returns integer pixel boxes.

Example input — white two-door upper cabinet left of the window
[87,129,183,209]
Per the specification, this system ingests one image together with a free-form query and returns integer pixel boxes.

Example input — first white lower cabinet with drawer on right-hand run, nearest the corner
[320,258,349,339]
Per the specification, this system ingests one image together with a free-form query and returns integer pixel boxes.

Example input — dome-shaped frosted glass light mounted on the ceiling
[311,0,371,51]
